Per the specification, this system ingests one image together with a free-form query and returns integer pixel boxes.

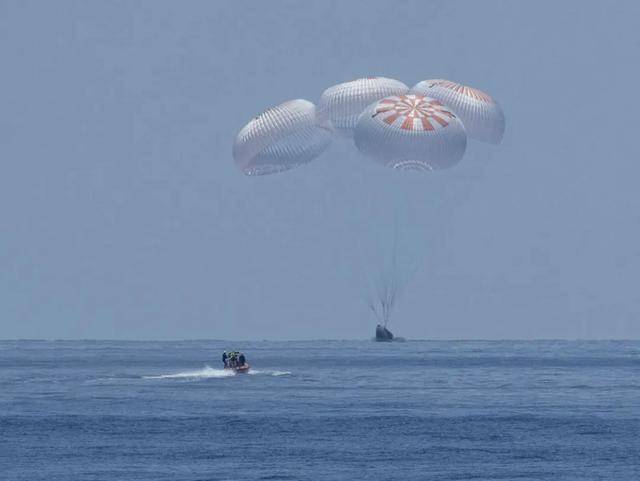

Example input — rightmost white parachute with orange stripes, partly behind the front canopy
[410,79,505,145]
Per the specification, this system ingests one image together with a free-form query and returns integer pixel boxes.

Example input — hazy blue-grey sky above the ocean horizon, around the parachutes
[0,0,640,339]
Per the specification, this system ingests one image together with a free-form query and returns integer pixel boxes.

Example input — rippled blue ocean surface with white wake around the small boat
[0,341,640,481]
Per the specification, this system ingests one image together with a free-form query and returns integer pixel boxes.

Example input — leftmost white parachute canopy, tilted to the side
[233,99,332,176]
